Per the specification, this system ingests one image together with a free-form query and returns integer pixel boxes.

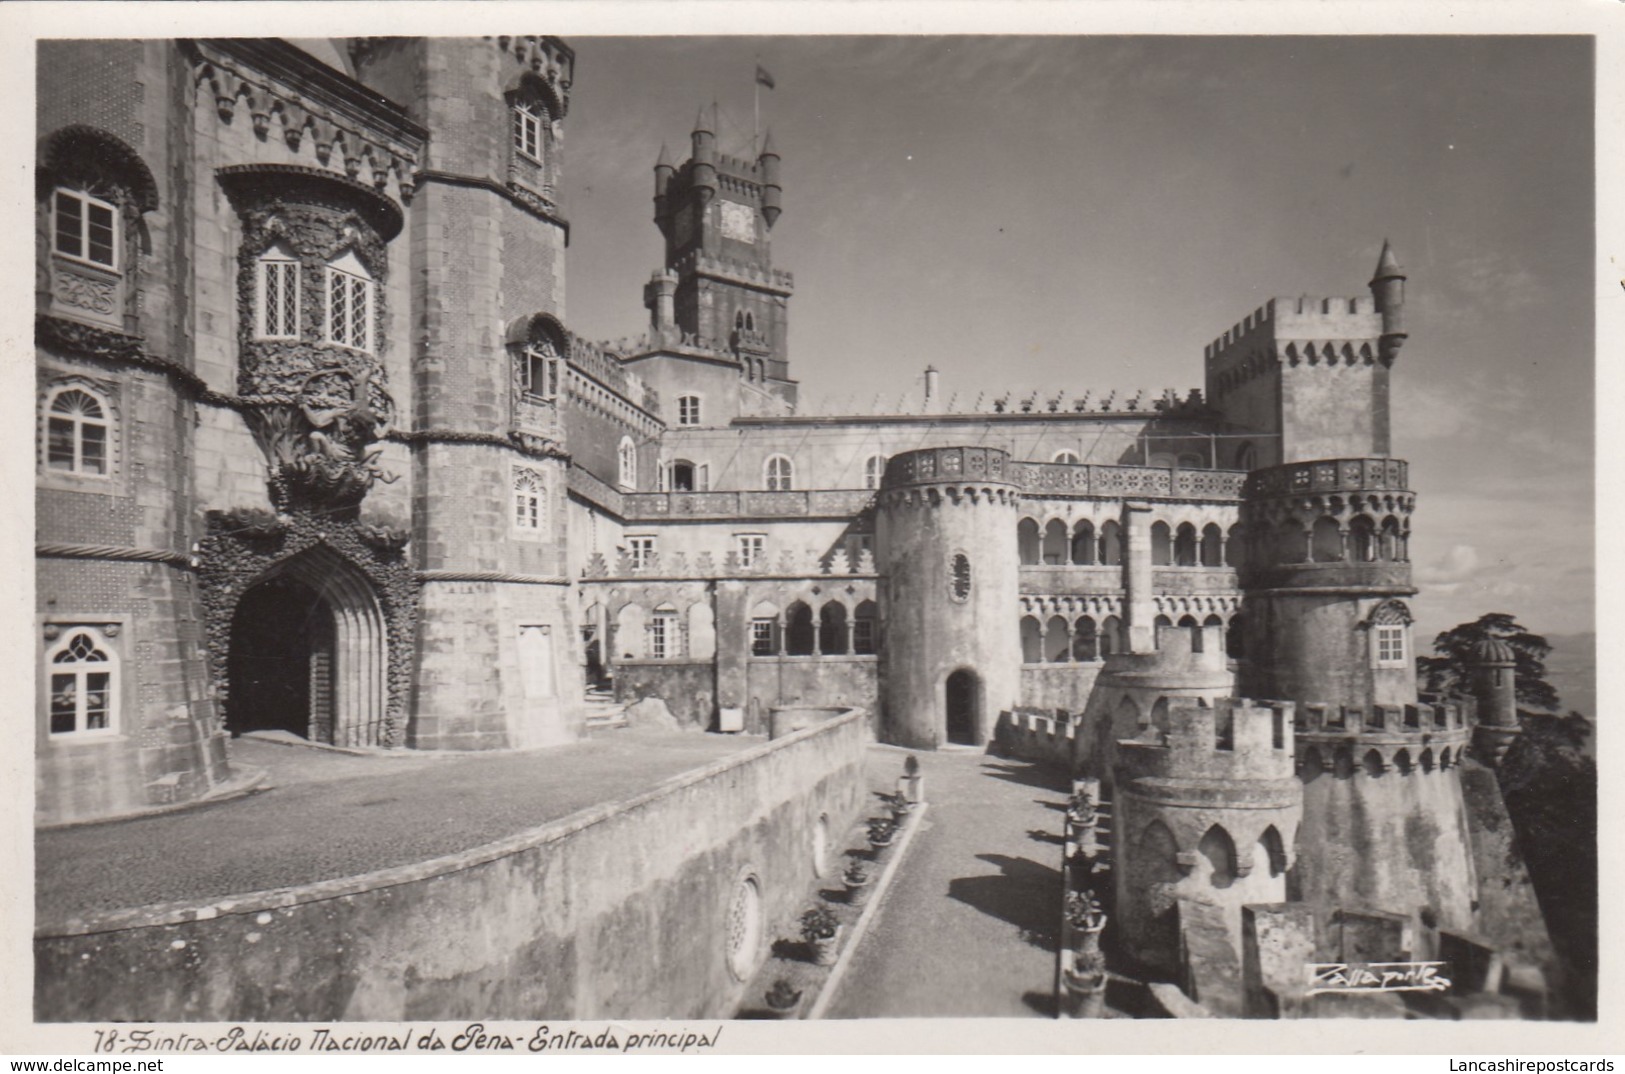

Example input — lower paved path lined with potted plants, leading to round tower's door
[827,747,1069,1019]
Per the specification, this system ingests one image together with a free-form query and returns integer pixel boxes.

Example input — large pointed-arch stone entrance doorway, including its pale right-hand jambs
[226,546,388,746]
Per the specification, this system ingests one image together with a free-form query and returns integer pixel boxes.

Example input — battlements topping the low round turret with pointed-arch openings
[1118,697,1294,782]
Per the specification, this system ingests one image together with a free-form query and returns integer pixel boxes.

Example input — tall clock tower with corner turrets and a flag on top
[647,106,795,393]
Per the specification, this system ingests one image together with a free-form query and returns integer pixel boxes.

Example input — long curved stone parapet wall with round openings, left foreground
[34,712,866,1022]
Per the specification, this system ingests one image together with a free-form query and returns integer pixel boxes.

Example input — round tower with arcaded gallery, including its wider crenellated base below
[1242,458,1477,929]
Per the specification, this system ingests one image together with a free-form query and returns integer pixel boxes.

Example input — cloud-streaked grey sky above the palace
[561,36,1596,643]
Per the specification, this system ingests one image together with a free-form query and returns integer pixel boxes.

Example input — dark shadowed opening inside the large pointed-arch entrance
[226,575,335,743]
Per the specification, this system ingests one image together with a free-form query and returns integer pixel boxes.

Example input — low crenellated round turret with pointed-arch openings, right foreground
[1113,699,1302,977]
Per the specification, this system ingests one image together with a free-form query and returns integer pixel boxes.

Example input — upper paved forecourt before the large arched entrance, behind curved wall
[34,731,747,925]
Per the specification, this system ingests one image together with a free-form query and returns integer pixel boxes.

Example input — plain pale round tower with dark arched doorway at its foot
[874,447,1021,749]
